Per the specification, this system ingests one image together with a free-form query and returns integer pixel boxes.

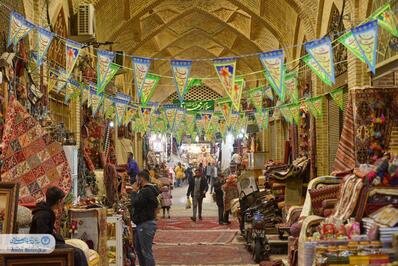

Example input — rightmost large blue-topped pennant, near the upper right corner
[351,20,378,74]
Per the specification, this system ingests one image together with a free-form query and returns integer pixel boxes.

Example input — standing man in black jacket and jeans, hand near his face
[131,171,159,266]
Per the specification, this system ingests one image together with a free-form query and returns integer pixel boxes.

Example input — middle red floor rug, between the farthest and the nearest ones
[155,229,238,245]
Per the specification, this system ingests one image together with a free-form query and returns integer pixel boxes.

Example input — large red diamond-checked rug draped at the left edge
[1,98,71,204]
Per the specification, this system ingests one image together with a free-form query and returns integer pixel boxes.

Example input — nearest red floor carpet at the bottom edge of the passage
[153,245,253,265]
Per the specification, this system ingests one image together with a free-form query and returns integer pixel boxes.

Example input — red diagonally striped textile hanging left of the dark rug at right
[332,93,355,175]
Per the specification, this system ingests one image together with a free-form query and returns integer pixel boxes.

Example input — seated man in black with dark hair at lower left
[29,187,87,266]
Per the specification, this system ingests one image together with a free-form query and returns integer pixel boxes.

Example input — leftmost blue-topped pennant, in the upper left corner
[7,11,35,47]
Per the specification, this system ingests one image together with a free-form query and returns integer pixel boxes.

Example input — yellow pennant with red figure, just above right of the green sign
[214,58,236,103]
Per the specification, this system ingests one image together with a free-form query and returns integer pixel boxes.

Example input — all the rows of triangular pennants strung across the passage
[3,3,398,143]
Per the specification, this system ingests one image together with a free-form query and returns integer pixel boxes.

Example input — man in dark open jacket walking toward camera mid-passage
[187,169,209,222]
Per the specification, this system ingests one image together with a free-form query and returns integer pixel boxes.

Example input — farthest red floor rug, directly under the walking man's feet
[158,217,239,230]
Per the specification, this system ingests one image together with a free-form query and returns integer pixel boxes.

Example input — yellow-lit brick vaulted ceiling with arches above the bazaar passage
[94,0,318,101]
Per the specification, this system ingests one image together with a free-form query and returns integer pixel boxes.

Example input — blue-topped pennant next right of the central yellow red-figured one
[259,50,285,102]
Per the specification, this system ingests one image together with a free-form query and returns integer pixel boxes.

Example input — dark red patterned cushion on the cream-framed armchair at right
[309,185,340,216]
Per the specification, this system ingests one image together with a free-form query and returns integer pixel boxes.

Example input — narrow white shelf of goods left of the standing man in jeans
[106,215,123,266]
